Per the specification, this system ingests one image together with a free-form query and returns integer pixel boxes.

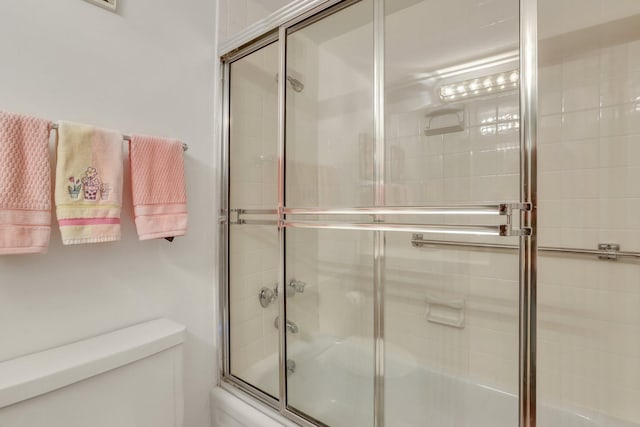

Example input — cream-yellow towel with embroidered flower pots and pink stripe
[55,122,123,245]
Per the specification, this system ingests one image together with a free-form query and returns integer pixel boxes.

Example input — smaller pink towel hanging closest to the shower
[129,135,187,240]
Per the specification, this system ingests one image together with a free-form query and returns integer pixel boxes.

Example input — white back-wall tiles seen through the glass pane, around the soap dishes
[385,88,519,404]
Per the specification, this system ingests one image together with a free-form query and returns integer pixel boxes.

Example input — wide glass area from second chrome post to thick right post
[283,0,522,427]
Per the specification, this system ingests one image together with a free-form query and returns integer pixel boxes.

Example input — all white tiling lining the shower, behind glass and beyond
[224,0,640,427]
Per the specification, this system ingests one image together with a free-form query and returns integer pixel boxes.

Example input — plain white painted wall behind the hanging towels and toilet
[0,0,216,427]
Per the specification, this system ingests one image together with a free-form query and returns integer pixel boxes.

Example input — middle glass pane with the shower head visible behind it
[284,0,374,427]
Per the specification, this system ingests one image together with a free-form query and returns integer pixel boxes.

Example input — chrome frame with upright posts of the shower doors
[217,0,538,427]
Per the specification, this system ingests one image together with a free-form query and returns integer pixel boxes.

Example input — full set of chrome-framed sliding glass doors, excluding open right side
[223,0,535,427]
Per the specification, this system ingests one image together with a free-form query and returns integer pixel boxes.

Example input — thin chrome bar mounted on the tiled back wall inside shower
[411,234,640,261]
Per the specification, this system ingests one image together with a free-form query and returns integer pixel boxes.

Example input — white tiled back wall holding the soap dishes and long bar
[378,35,640,427]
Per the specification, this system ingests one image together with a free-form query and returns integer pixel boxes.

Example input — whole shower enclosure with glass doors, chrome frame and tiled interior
[220,0,640,427]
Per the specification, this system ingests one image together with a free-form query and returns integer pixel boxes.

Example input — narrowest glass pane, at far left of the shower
[227,43,280,398]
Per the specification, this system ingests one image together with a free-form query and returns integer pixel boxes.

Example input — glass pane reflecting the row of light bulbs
[384,0,520,427]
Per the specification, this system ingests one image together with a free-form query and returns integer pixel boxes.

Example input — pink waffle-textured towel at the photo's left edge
[0,111,51,255]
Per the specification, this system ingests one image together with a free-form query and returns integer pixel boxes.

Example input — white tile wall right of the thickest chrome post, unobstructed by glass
[538,15,640,423]
